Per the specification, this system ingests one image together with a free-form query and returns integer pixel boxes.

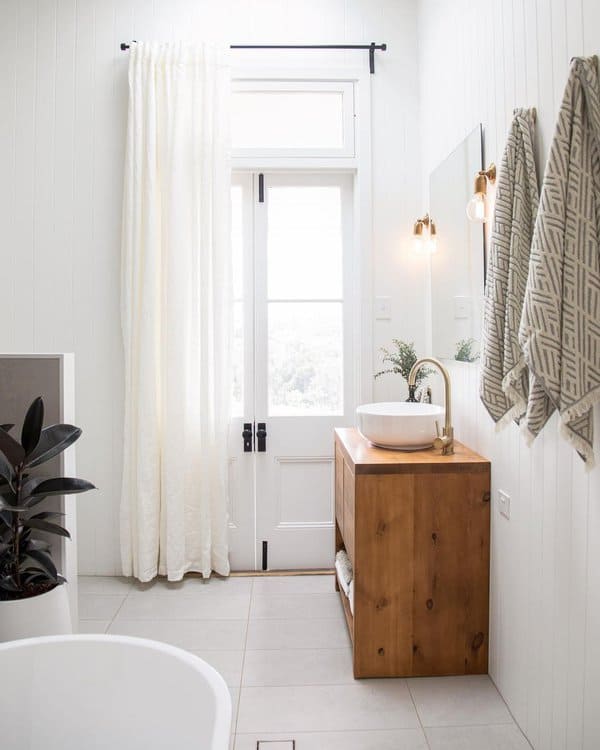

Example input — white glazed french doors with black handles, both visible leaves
[230,172,356,570]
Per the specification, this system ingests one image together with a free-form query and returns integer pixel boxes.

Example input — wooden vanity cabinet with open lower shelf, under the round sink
[335,428,490,677]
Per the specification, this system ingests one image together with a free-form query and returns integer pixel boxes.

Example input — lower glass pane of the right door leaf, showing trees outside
[268,302,344,416]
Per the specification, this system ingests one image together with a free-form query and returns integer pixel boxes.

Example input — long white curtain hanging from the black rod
[121,42,231,581]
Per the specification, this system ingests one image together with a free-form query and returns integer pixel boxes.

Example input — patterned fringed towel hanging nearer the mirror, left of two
[479,109,539,427]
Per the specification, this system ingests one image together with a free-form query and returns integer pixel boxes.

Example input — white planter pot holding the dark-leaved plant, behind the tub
[0,584,73,642]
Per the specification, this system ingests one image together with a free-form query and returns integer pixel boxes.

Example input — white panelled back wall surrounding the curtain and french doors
[0,0,425,574]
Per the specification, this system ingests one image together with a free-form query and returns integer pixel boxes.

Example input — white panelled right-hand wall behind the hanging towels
[419,0,600,750]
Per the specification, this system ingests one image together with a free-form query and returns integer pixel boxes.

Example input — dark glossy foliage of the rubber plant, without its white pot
[0,397,95,601]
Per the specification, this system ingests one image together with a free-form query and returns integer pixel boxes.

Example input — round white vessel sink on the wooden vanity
[356,401,444,451]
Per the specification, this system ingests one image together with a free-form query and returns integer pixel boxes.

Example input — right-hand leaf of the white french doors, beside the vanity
[255,174,354,569]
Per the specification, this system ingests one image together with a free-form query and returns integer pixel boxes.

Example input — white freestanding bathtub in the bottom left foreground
[0,635,231,750]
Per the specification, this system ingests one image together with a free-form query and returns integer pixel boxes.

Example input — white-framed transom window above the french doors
[231,79,355,157]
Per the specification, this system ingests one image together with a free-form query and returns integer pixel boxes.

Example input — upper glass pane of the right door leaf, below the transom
[267,185,343,299]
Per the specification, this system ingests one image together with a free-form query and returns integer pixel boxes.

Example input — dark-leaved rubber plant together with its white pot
[0,398,94,641]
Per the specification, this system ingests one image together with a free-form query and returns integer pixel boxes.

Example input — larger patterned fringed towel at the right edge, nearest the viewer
[519,57,600,466]
